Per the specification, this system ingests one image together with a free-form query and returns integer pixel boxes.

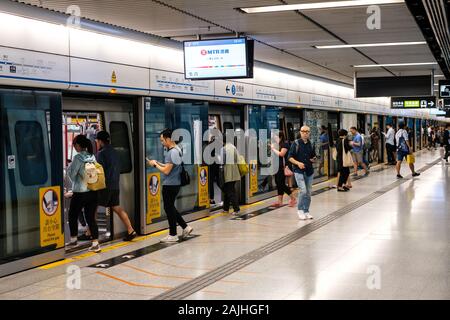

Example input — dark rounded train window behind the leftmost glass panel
[14,121,48,186]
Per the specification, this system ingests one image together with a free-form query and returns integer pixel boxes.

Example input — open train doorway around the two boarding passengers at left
[63,97,138,245]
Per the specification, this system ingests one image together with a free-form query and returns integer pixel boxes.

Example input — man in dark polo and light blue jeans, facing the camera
[288,126,317,220]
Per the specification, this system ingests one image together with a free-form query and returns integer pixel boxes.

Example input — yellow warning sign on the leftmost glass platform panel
[39,186,64,248]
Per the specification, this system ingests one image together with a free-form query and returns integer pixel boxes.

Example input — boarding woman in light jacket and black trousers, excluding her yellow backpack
[67,134,101,252]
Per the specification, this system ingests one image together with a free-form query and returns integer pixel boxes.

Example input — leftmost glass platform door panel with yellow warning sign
[0,89,64,276]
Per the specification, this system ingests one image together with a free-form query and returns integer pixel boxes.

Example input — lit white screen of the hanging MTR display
[184,38,249,80]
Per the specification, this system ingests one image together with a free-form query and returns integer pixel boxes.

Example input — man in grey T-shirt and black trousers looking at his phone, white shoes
[147,129,193,243]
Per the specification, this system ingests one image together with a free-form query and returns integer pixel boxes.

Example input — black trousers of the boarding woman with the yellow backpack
[69,191,98,239]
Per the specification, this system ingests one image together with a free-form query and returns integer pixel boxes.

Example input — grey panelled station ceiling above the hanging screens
[13,0,442,84]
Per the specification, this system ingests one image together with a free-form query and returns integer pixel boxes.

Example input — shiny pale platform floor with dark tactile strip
[0,149,450,300]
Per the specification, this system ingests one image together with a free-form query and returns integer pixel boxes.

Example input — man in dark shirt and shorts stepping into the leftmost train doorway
[95,131,136,241]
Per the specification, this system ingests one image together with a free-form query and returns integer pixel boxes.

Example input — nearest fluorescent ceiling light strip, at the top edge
[240,0,405,13]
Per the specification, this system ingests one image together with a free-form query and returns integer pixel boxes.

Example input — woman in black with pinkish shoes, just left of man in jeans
[272,131,297,207]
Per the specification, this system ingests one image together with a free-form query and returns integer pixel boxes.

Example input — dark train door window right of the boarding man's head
[109,121,133,173]
